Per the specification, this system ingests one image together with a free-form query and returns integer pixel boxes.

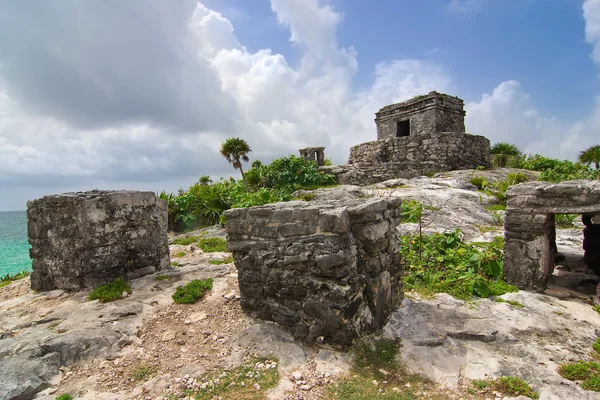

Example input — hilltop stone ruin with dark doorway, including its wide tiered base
[324,92,491,185]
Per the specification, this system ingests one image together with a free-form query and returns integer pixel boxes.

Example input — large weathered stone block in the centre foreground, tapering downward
[225,198,403,348]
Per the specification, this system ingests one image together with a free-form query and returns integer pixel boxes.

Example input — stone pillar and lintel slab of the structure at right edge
[503,181,600,291]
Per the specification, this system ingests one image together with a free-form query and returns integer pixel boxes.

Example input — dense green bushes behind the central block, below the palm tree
[158,156,337,234]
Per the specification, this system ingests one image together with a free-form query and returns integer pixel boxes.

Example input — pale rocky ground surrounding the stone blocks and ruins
[0,170,600,400]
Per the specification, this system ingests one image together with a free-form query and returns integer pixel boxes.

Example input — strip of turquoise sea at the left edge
[0,211,31,276]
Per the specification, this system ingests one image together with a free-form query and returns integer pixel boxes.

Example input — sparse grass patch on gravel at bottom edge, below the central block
[184,357,280,400]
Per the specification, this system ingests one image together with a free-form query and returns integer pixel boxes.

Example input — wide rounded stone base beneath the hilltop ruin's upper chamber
[323,132,491,185]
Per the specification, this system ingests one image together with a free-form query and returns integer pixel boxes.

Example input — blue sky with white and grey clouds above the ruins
[0,0,600,211]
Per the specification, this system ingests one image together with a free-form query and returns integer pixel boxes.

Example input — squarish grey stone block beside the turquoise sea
[27,190,170,291]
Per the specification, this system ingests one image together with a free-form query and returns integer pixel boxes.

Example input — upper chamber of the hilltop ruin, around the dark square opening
[375,92,465,140]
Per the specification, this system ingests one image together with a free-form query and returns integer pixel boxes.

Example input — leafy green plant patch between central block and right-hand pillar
[400,229,517,300]
